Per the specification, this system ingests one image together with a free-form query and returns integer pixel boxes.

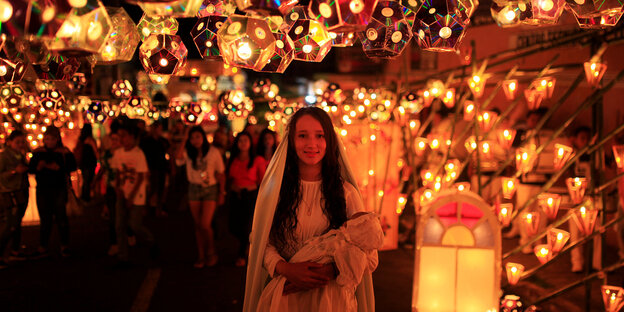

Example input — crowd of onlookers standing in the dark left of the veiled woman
[0,117,278,268]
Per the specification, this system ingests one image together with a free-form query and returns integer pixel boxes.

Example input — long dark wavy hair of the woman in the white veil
[269,107,347,251]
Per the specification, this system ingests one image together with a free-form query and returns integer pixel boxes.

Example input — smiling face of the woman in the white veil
[295,115,327,166]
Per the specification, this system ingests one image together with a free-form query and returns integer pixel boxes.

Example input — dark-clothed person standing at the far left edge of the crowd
[0,130,29,269]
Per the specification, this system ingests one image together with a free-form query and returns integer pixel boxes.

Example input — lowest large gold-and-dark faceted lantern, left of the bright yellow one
[139,34,188,75]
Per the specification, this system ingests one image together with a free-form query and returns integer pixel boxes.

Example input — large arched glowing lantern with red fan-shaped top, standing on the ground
[412,190,501,312]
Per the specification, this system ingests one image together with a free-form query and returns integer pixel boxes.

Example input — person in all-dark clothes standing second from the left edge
[29,126,76,258]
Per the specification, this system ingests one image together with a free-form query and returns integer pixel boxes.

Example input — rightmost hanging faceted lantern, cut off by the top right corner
[566,0,624,29]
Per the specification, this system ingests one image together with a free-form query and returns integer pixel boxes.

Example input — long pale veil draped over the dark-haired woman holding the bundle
[243,125,375,312]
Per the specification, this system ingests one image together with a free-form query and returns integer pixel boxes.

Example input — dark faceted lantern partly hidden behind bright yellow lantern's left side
[191,15,227,59]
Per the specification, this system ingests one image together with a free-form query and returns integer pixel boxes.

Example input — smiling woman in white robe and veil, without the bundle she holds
[243,107,376,312]
